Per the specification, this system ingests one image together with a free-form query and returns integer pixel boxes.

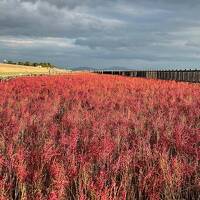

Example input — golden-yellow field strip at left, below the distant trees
[0,63,67,78]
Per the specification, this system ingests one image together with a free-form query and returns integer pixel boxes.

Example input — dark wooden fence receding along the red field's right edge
[93,70,200,83]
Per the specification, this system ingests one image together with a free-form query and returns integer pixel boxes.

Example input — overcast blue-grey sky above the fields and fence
[0,0,200,68]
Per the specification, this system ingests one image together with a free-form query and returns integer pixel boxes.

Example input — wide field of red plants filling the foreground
[0,74,200,200]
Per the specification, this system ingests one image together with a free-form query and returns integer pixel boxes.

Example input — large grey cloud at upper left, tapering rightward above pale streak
[0,0,120,38]
